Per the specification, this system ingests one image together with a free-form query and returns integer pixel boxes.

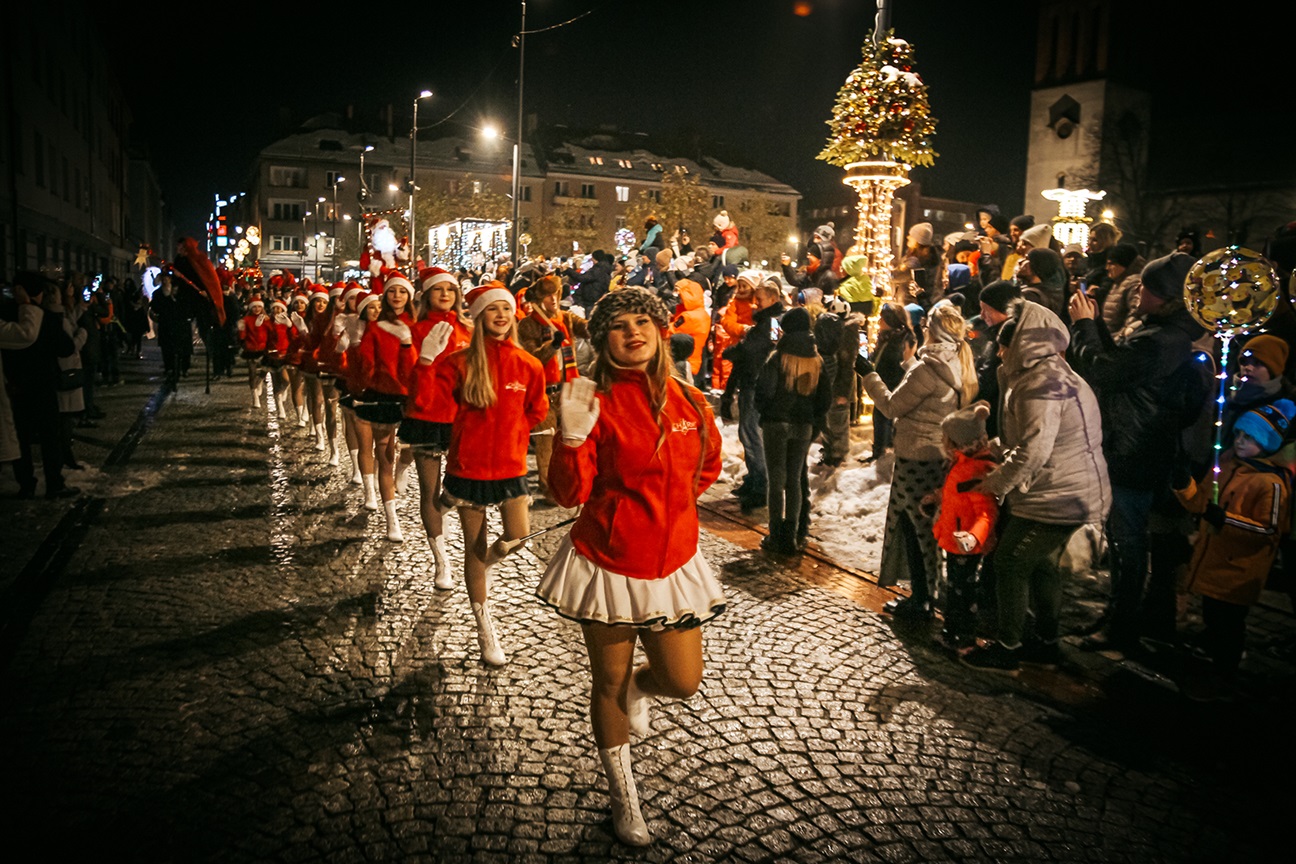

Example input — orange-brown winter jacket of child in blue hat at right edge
[1175,452,1291,605]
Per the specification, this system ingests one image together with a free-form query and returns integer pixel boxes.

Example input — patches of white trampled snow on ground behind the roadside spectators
[719,421,894,573]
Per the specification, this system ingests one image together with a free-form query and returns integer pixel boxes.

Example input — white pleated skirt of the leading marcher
[535,535,724,631]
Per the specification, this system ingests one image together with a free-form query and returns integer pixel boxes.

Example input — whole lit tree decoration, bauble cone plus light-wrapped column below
[818,30,937,294]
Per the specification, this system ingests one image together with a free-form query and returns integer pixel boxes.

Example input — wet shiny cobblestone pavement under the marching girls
[0,347,1296,863]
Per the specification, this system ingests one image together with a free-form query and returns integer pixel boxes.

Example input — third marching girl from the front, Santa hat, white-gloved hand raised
[398,267,473,591]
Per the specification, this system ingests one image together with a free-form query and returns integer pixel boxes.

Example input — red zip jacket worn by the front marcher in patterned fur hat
[548,370,721,579]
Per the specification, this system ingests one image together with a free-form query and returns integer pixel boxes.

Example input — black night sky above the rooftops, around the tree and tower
[93,0,1296,239]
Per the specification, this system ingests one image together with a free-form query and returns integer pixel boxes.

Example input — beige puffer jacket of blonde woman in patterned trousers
[864,342,963,461]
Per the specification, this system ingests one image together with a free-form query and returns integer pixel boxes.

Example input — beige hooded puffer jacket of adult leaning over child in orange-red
[984,302,1112,525]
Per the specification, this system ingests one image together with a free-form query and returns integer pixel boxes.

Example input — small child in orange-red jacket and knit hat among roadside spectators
[932,402,999,650]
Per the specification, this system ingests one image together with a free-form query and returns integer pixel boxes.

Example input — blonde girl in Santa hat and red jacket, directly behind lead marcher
[433,282,550,666]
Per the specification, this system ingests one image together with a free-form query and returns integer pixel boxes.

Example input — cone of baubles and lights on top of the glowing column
[818,31,936,168]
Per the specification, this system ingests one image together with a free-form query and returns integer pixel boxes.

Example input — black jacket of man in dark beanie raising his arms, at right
[1069,306,1205,490]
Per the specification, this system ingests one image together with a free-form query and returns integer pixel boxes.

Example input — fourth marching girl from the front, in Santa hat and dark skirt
[354,275,419,543]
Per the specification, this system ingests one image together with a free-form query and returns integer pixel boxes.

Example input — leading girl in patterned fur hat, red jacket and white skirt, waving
[535,288,724,846]
